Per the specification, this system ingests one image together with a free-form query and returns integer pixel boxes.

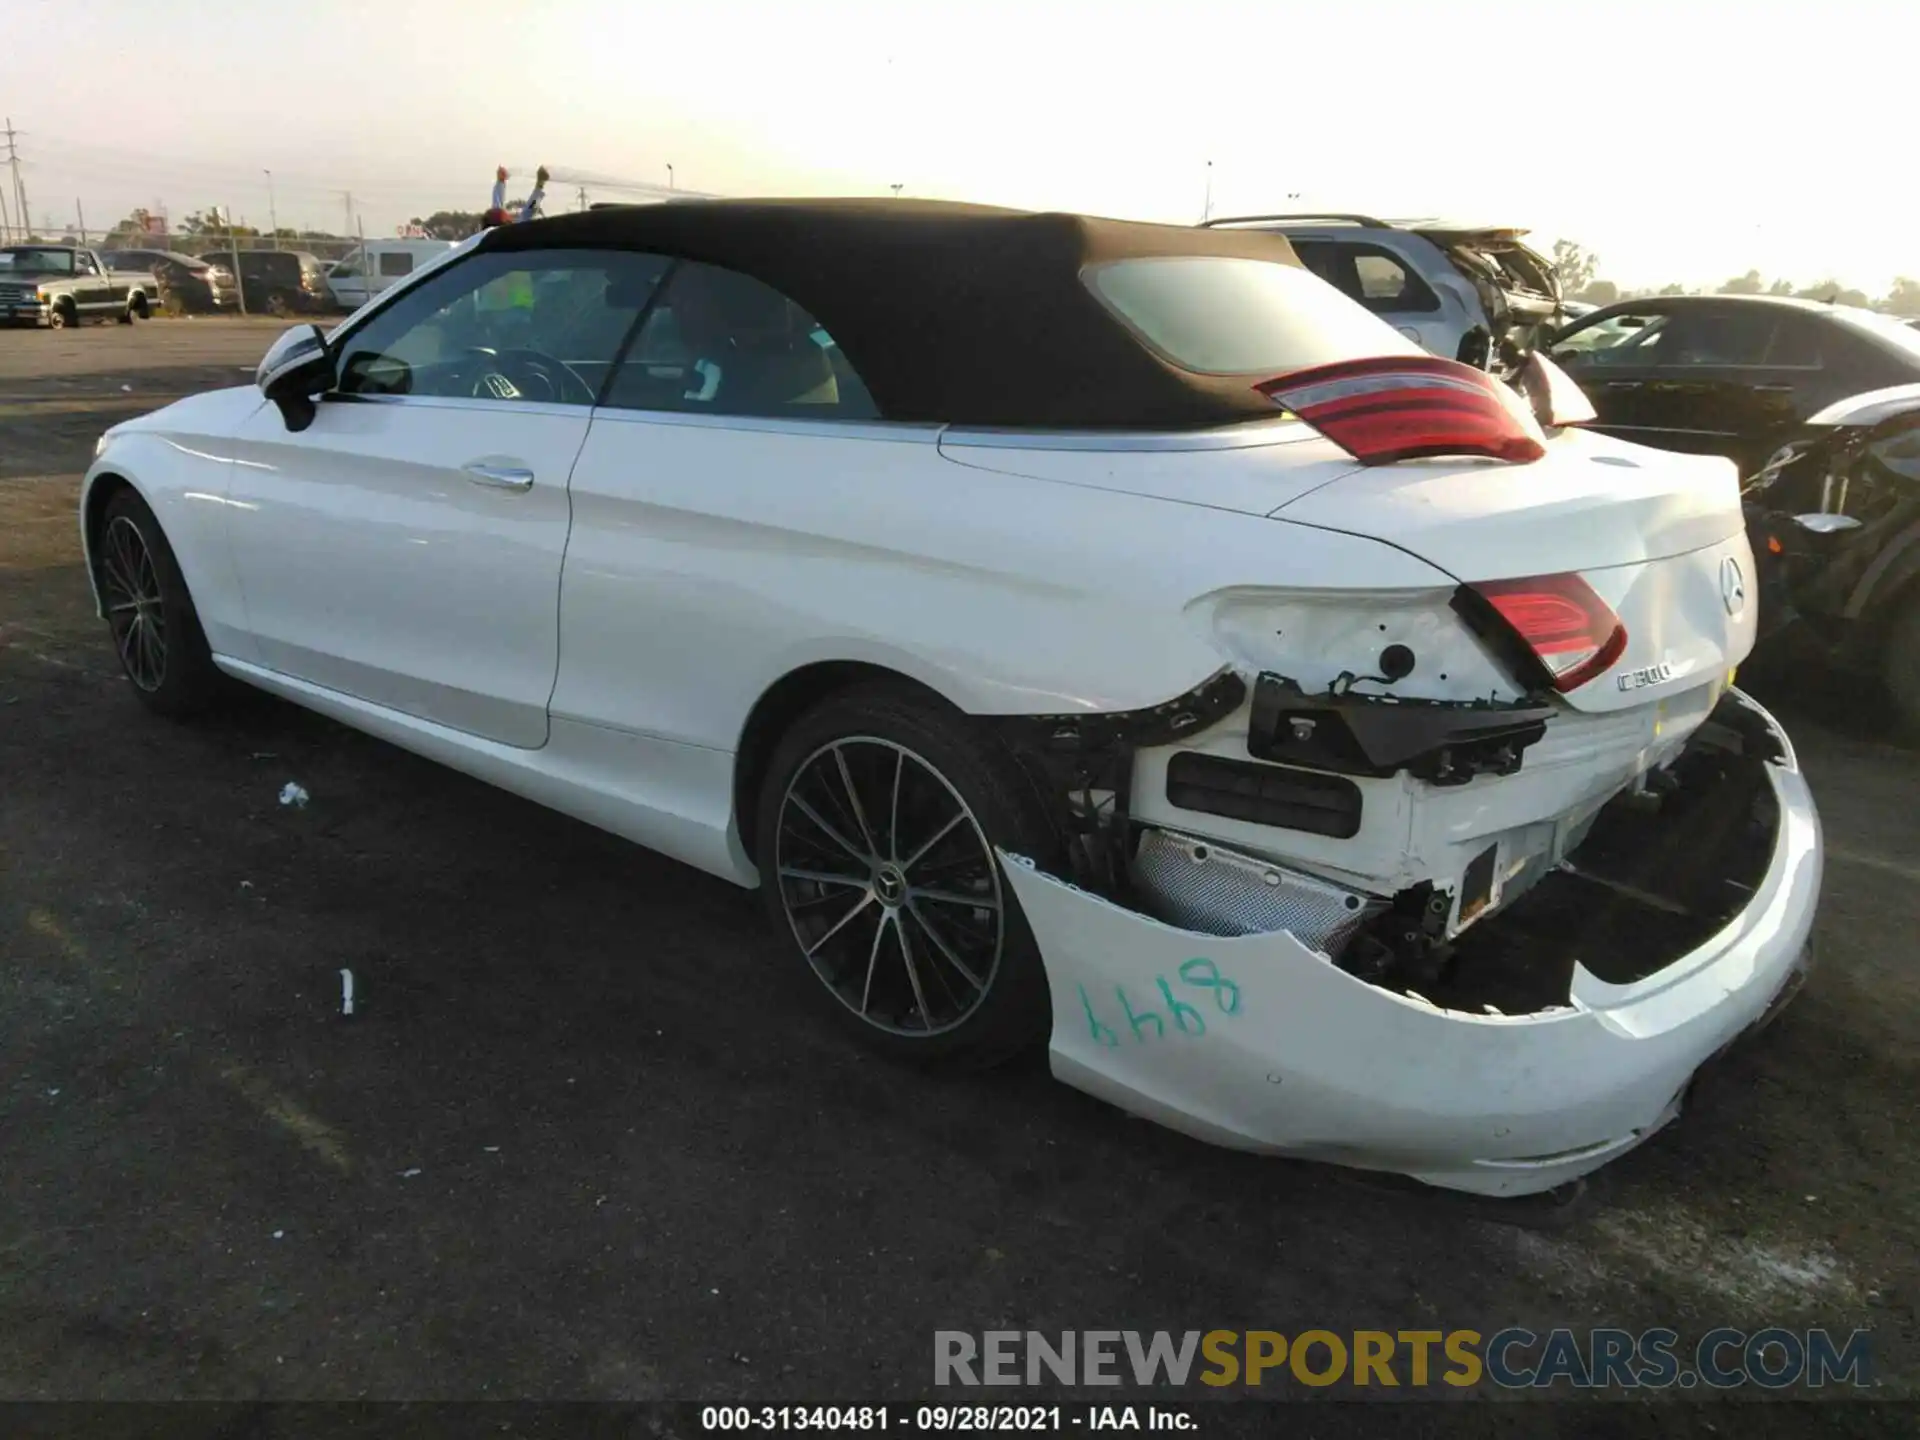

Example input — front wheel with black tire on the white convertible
[94,490,223,718]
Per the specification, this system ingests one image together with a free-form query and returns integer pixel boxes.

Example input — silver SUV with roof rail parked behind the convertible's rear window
[1206,215,1561,372]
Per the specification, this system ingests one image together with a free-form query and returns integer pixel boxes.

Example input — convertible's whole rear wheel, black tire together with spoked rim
[756,684,1054,1068]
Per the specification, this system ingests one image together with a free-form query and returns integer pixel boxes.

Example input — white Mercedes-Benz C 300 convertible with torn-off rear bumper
[81,200,1820,1194]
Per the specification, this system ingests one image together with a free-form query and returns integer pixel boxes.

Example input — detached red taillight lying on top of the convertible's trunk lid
[1258,355,1546,465]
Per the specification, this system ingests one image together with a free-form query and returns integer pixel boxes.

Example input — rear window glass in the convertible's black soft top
[1081,255,1423,378]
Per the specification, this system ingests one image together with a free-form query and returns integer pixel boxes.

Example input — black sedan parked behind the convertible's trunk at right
[1548,296,1920,474]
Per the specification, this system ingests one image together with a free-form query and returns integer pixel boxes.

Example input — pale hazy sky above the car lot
[0,0,1920,294]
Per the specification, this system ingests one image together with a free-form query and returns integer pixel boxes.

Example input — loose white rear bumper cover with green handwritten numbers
[1002,691,1822,1194]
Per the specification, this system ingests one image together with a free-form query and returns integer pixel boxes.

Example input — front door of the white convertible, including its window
[228,250,664,747]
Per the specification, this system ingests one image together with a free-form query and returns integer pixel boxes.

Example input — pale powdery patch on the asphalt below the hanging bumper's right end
[1509,1204,1860,1309]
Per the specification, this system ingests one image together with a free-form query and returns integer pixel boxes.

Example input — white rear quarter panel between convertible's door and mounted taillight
[553,411,1446,749]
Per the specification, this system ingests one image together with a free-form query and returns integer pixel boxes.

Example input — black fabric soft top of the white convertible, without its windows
[480,200,1300,430]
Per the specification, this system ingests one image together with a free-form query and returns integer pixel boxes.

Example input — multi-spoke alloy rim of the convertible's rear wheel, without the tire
[774,735,1006,1037]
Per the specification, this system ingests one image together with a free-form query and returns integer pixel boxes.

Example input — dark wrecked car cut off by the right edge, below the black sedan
[1747,384,1920,743]
